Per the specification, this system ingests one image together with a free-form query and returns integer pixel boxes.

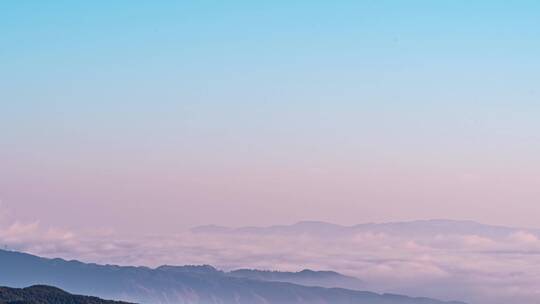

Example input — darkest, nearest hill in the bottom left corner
[0,285,132,304]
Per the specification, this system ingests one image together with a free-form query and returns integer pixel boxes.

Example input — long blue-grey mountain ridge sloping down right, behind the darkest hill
[0,250,464,304]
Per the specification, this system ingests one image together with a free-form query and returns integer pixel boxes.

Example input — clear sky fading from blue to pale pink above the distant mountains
[0,0,540,232]
